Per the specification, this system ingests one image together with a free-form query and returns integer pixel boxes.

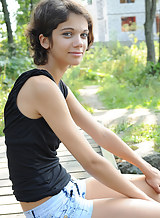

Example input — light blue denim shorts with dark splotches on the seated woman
[24,179,93,218]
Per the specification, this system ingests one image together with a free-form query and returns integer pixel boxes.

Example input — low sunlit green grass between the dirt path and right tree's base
[99,78,160,109]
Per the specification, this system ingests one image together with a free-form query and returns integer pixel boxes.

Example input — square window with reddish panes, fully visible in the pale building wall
[121,17,136,32]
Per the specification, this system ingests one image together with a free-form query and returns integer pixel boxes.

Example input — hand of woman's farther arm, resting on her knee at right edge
[145,167,160,194]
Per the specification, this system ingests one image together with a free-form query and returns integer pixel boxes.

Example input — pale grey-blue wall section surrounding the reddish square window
[106,0,145,41]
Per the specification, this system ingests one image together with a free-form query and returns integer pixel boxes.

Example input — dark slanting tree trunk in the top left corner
[0,0,13,46]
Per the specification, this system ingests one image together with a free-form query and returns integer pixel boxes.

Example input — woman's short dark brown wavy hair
[26,0,94,65]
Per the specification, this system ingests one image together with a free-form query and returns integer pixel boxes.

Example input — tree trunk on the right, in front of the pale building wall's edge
[144,0,156,63]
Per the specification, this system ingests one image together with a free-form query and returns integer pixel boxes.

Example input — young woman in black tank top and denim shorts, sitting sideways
[4,0,160,218]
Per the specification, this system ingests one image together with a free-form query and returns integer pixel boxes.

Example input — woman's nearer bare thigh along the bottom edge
[92,198,160,218]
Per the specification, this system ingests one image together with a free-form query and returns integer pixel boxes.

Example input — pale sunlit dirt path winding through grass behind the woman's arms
[79,86,160,156]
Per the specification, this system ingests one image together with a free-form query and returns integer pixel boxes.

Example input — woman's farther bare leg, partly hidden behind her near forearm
[85,175,160,202]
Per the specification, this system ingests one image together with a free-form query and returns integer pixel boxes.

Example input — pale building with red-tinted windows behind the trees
[88,0,160,42]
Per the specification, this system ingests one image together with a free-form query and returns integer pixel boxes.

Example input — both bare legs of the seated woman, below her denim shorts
[86,175,160,218]
